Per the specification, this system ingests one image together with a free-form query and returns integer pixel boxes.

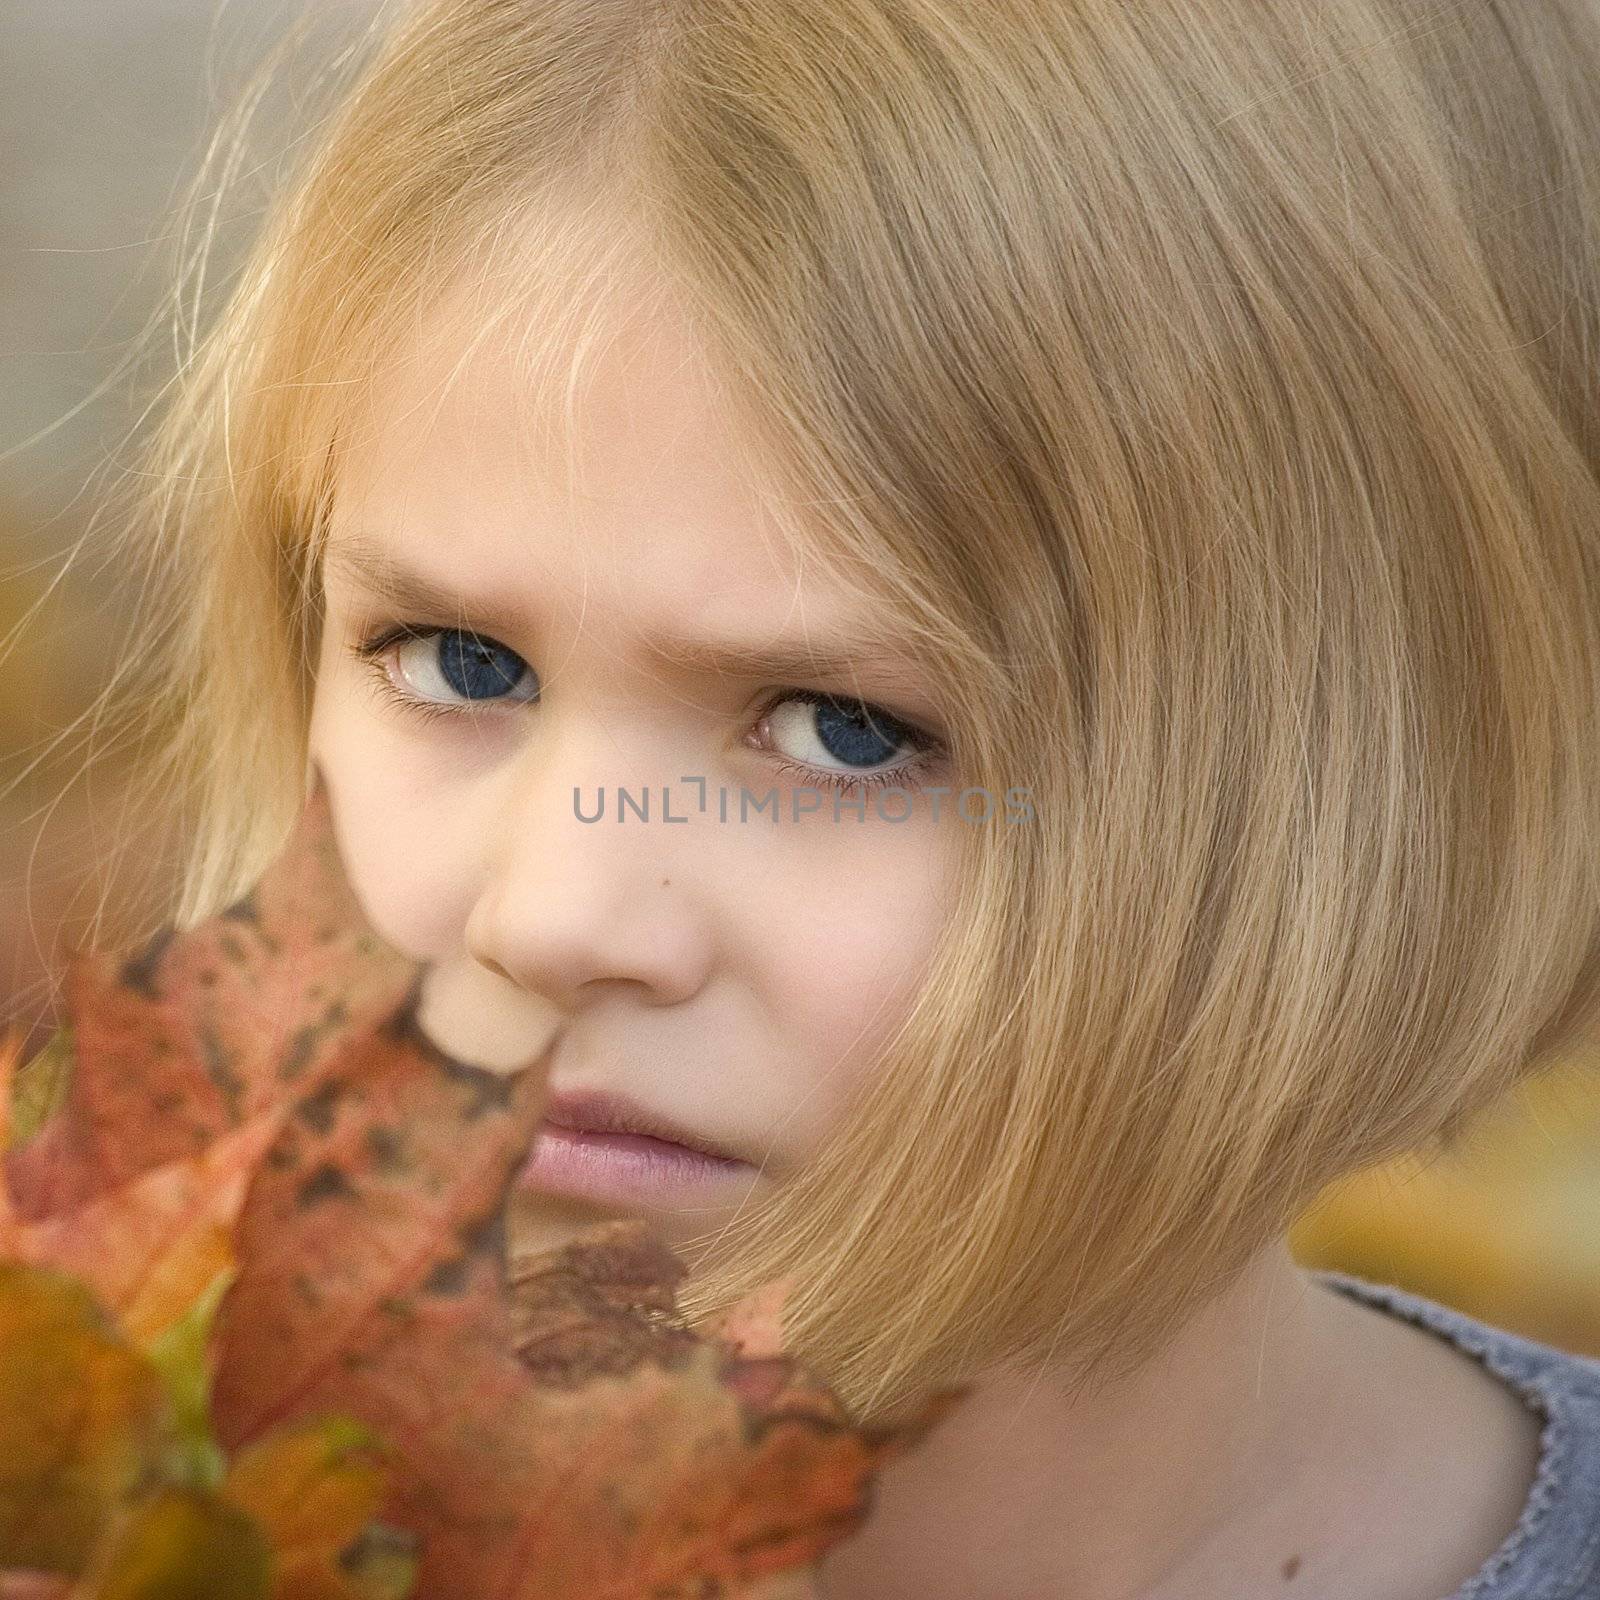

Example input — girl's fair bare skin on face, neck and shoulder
[300,249,1538,1600]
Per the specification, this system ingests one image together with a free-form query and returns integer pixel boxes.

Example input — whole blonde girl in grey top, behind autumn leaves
[62,0,1600,1600]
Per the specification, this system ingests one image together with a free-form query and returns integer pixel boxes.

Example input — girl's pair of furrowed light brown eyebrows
[323,531,930,699]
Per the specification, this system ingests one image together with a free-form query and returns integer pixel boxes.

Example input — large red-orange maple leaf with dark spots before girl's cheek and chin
[8,789,955,1600]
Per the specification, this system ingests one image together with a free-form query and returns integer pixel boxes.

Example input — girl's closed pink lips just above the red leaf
[517,1091,755,1205]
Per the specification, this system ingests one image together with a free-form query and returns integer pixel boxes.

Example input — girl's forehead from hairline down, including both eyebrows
[325,270,917,691]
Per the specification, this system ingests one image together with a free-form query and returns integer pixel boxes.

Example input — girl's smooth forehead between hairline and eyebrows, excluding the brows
[333,268,803,590]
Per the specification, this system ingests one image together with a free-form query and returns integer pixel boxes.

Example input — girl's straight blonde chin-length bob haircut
[37,0,1600,1416]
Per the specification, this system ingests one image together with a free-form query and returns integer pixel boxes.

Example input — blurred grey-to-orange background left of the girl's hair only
[0,0,379,1040]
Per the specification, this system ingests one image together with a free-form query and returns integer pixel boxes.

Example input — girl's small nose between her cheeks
[466,739,712,1014]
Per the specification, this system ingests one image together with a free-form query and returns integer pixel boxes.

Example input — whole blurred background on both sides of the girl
[9,0,1600,1355]
